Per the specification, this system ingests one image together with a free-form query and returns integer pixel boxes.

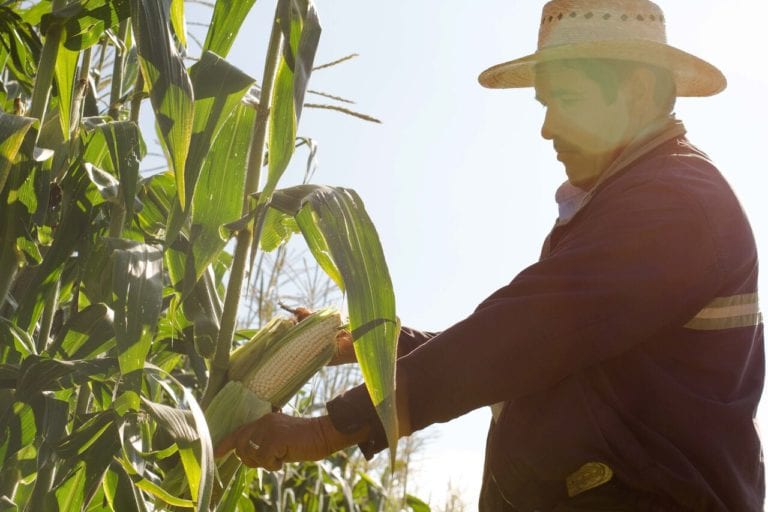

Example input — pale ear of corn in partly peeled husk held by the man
[205,309,341,444]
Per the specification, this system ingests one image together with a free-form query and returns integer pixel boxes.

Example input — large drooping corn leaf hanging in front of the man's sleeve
[262,185,399,463]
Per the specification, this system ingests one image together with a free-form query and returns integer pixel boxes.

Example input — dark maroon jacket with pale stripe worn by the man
[328,136,764,512]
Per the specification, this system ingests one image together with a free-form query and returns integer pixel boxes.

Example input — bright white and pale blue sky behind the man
[176,0,768,510]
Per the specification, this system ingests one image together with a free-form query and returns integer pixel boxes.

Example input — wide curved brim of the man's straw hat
[478,40,727,96]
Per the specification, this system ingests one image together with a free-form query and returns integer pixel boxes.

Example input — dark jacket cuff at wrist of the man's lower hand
[325,384,389,460]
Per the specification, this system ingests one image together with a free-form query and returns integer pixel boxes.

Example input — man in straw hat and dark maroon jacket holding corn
[218,0,764,512]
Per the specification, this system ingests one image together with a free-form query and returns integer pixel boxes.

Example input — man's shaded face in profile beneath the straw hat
[535,62,637,189]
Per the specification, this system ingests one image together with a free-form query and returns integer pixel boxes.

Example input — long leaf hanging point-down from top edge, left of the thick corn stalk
[131,0,195,209]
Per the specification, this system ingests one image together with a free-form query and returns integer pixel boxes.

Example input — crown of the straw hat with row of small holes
[538,0,667,50]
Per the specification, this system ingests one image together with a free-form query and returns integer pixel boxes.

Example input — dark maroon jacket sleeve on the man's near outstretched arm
[324,173,722,452]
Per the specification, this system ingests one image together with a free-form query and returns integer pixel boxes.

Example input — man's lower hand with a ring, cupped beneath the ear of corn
[214,413,368,471]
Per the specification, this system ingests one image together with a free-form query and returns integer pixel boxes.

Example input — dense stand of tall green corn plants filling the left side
[0,0,397,512]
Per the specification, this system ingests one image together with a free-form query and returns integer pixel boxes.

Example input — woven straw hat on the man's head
[479,0,726,96]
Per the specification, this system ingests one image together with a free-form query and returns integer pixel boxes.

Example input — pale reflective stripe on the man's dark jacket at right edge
[685,293,763,331]
